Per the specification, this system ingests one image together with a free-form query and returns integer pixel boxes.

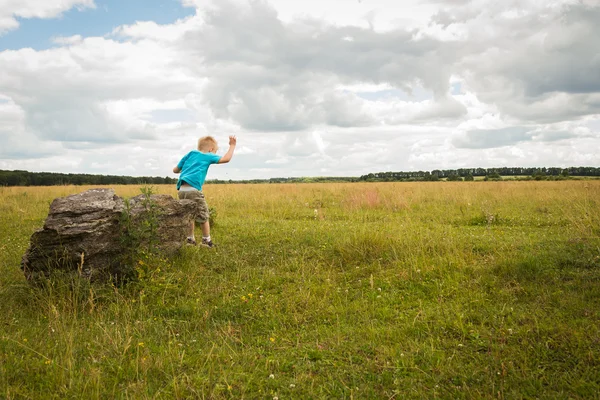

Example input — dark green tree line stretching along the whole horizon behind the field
[0,167,600,186]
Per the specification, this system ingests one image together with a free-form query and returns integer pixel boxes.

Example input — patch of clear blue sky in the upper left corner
[0,0,195,51]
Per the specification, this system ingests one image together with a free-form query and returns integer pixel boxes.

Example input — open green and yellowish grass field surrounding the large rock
[0,181,600,399]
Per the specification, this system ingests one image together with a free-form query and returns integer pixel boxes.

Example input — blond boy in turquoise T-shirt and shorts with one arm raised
[173,136,237,247]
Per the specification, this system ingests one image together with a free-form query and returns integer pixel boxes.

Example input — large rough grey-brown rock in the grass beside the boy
[21,189,194,281]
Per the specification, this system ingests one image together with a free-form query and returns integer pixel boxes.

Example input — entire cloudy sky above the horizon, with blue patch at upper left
[0,0,600,179]
